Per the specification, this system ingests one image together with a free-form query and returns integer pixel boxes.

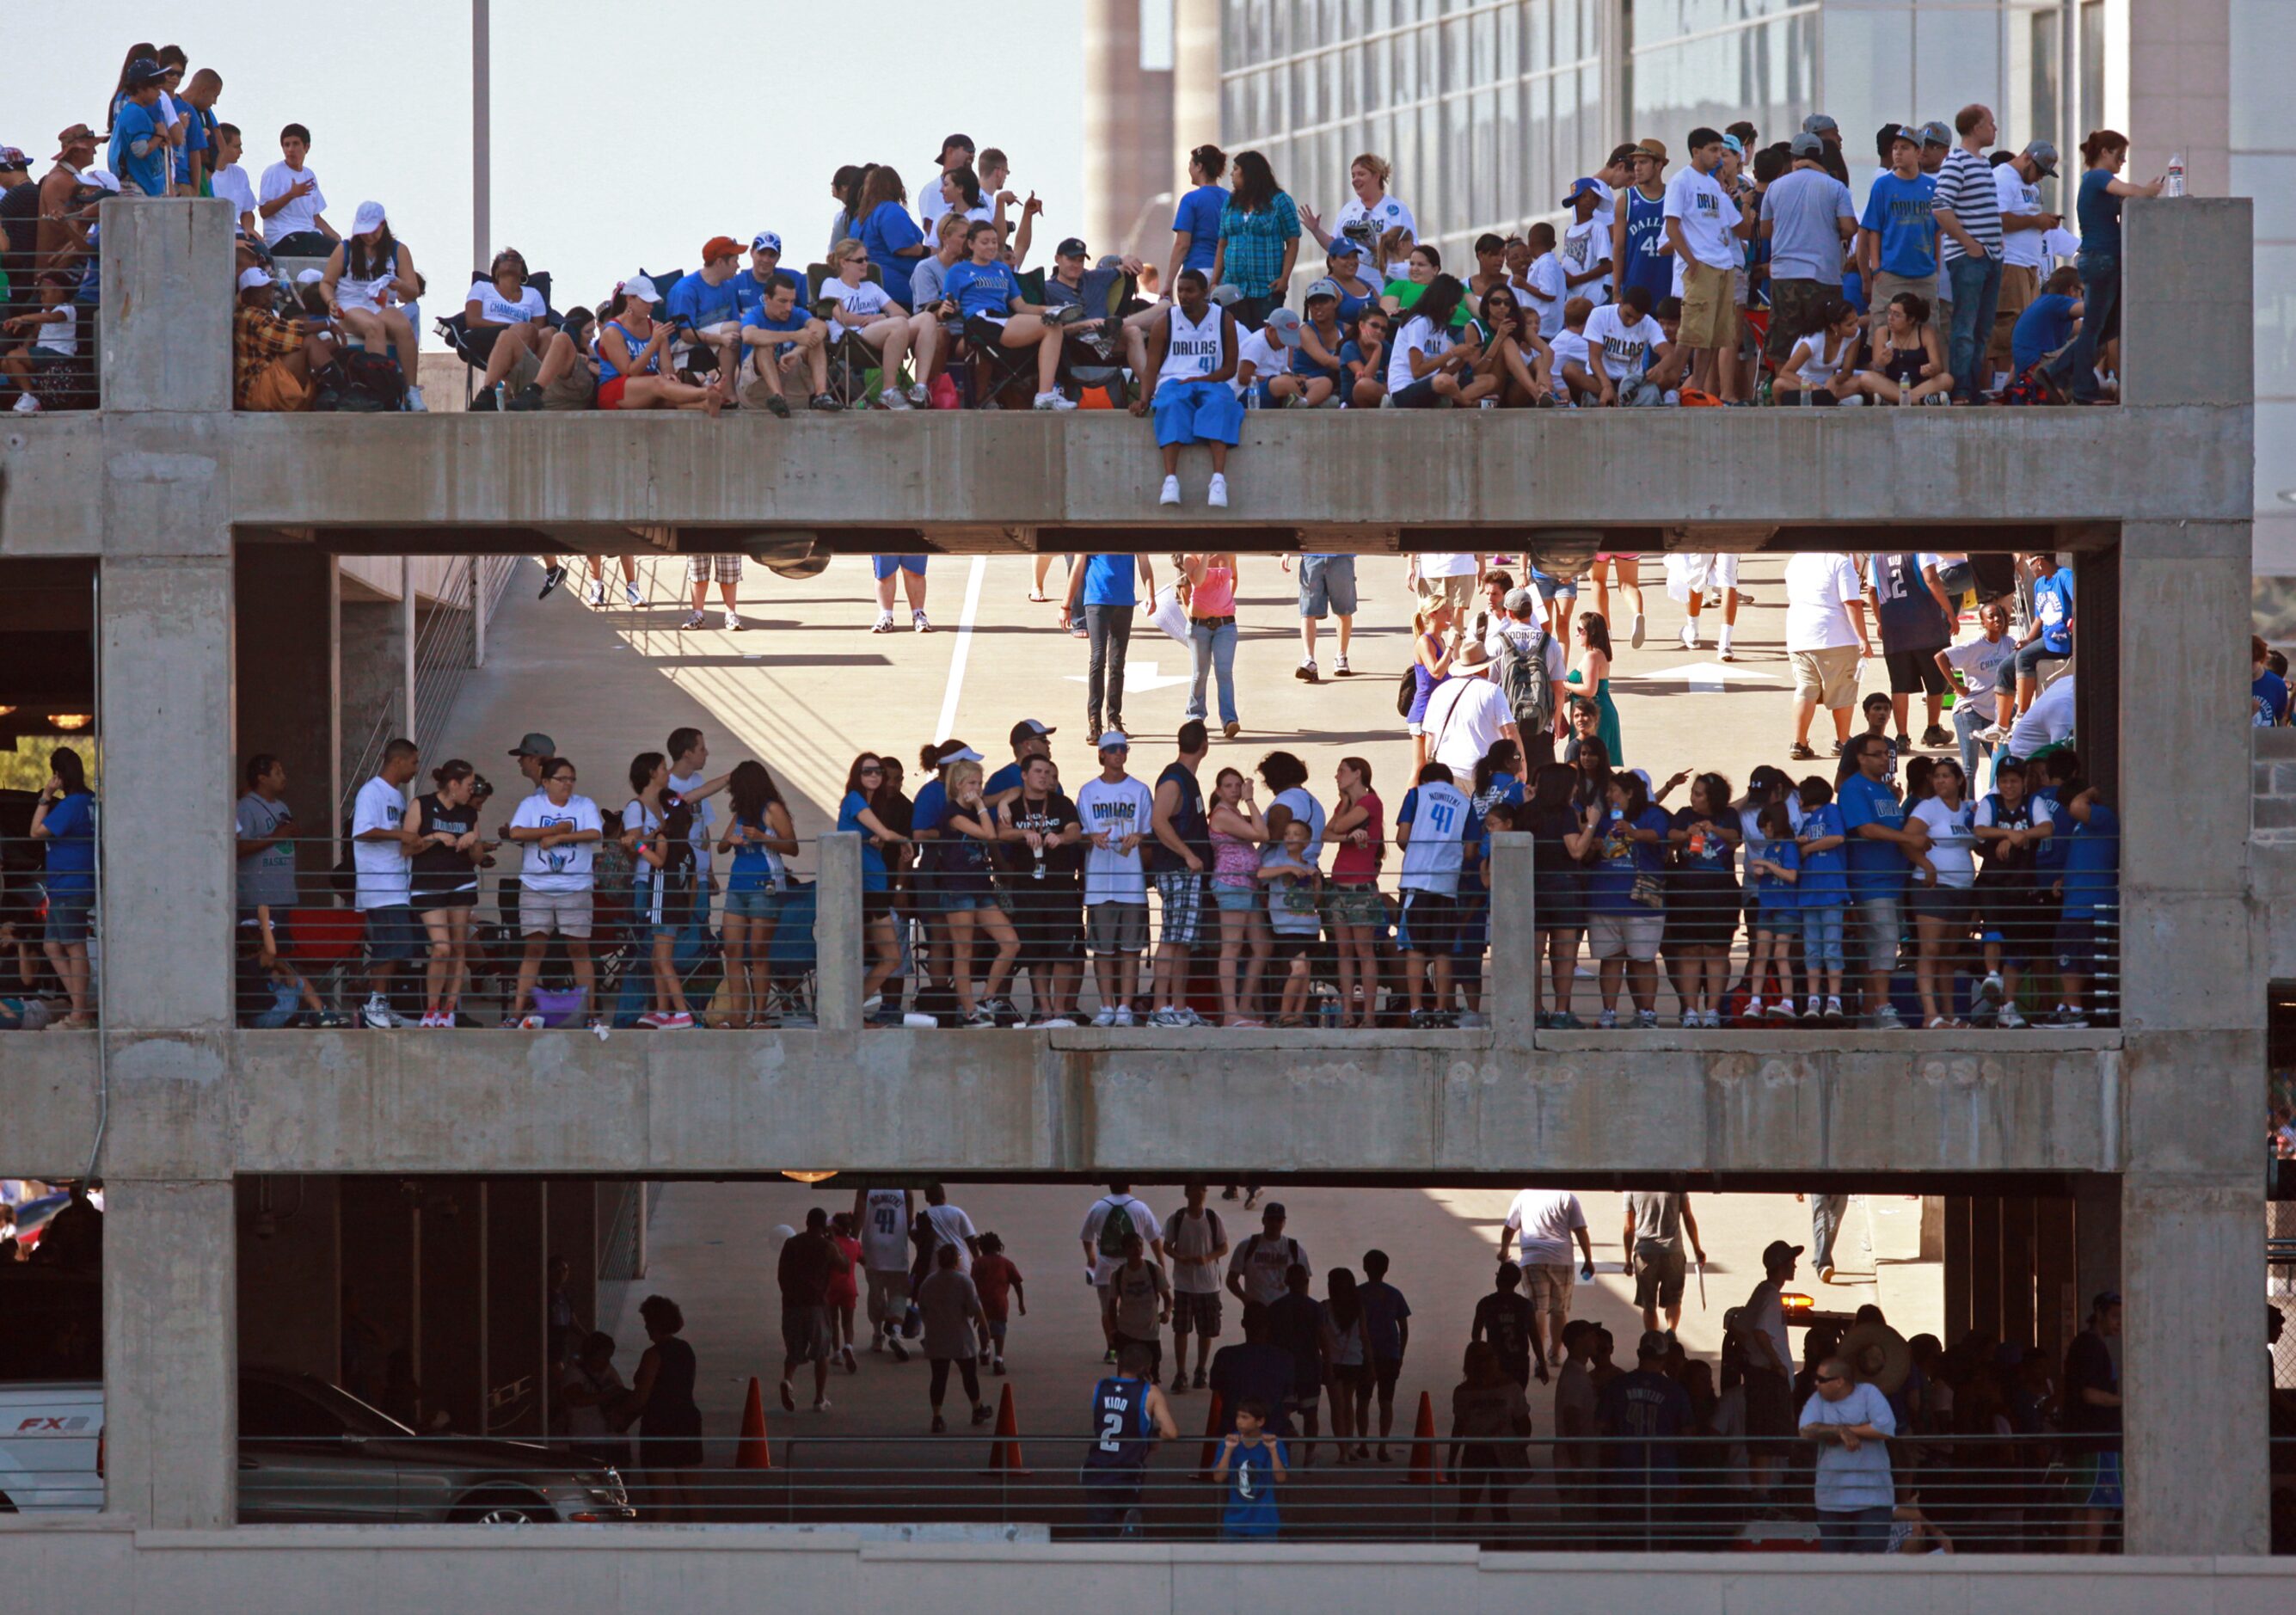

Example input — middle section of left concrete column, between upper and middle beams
[99,558,236,1038]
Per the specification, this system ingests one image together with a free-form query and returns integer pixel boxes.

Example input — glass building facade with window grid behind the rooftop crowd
[1219,0,2078,273]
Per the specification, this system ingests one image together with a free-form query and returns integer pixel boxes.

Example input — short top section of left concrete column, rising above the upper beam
[99,198,236,414]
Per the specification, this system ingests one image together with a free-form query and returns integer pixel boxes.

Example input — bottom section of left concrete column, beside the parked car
[103,1178,239,1530]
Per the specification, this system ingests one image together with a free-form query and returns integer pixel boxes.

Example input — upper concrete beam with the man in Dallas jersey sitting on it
[0,404,2252,556]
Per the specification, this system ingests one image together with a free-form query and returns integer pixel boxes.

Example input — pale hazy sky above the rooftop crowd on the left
[27,0,1082,312]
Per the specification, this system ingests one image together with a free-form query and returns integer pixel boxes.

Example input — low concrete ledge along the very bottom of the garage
[0,1526,2296,1615]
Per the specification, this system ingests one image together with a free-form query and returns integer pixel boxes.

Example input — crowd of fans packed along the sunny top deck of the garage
[0,44,2167,432]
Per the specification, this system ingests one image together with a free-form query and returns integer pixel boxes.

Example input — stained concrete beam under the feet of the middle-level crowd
[0,1029,2121,1181]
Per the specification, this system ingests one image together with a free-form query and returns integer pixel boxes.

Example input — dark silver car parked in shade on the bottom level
[239,1366,638,1526]
